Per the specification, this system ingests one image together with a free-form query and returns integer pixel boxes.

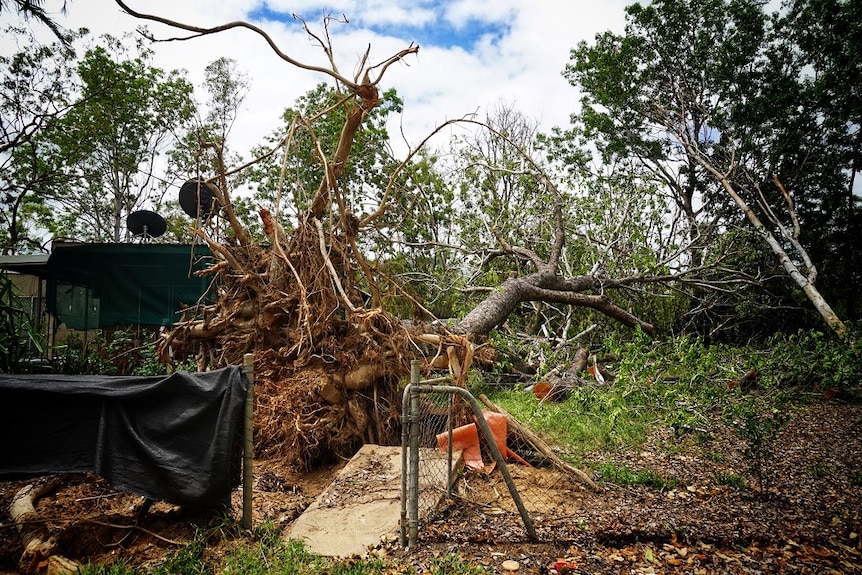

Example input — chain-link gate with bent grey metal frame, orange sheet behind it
[402,364,594,545]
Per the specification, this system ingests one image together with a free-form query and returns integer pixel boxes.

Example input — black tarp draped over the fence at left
[0,366,248,507]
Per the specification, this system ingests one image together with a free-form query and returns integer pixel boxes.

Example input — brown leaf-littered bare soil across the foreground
[0,400,862,574]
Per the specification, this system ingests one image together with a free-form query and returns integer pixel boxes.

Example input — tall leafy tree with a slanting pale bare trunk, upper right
[566,0,842,340]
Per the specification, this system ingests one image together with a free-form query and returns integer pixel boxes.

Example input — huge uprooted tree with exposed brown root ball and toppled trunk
[117,0,652,467]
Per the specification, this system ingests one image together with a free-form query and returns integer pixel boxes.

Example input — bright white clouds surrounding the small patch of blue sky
[0,0,630,155]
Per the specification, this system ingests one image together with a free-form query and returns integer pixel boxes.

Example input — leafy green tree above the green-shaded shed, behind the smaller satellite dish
[45,36,194,242]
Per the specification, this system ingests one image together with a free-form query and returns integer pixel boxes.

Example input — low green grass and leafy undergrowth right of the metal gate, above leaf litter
[486,331,860,472]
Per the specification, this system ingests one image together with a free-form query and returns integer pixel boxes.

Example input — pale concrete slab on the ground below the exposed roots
[287,445,461,557]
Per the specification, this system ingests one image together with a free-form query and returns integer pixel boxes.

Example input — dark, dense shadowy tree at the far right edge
[776,0,862,320]
